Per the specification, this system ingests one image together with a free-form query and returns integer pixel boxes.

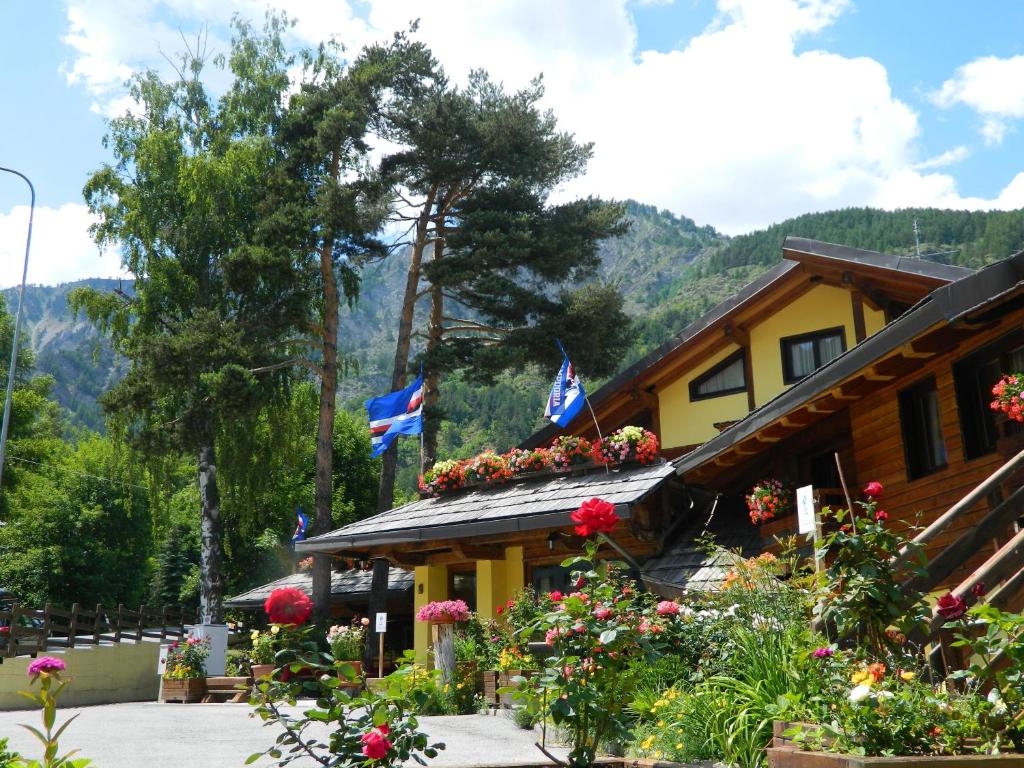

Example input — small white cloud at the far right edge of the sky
[932,56,1024,144]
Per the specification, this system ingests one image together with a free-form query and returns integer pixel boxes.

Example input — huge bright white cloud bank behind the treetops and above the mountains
[56,0,1024,246]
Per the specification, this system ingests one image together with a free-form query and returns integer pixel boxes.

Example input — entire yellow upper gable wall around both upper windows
[657,285,886,449]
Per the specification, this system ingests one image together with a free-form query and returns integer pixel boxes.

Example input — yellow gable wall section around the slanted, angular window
[657,344,746,447]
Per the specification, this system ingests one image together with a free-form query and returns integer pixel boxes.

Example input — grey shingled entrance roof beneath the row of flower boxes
[296,462,673,552]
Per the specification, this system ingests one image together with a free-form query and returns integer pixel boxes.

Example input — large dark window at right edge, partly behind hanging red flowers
[953,331,1024,460]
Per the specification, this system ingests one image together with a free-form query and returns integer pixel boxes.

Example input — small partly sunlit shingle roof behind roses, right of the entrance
[640,518,762,597]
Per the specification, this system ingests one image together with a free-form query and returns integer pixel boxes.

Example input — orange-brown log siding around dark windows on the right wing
[849,303,1024,587]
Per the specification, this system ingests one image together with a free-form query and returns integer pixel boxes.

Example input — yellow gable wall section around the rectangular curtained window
[751,285,885,407]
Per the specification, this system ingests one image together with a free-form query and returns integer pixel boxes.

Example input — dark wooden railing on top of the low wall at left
[0,603,196,662]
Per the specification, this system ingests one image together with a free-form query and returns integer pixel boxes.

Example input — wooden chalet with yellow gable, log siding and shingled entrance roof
[297,238,1024,652]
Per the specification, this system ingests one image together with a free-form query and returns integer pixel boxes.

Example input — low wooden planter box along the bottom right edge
[765,720,1024,768]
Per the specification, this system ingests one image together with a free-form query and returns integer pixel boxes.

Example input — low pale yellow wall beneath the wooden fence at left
[0,642,160,712]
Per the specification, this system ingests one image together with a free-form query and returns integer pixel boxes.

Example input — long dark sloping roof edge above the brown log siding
[673,251,1024,475]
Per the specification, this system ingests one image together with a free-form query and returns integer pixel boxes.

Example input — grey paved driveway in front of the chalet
[0,702,564,768]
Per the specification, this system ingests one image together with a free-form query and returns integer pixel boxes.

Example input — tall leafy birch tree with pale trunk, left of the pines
[72,16,307,622]
